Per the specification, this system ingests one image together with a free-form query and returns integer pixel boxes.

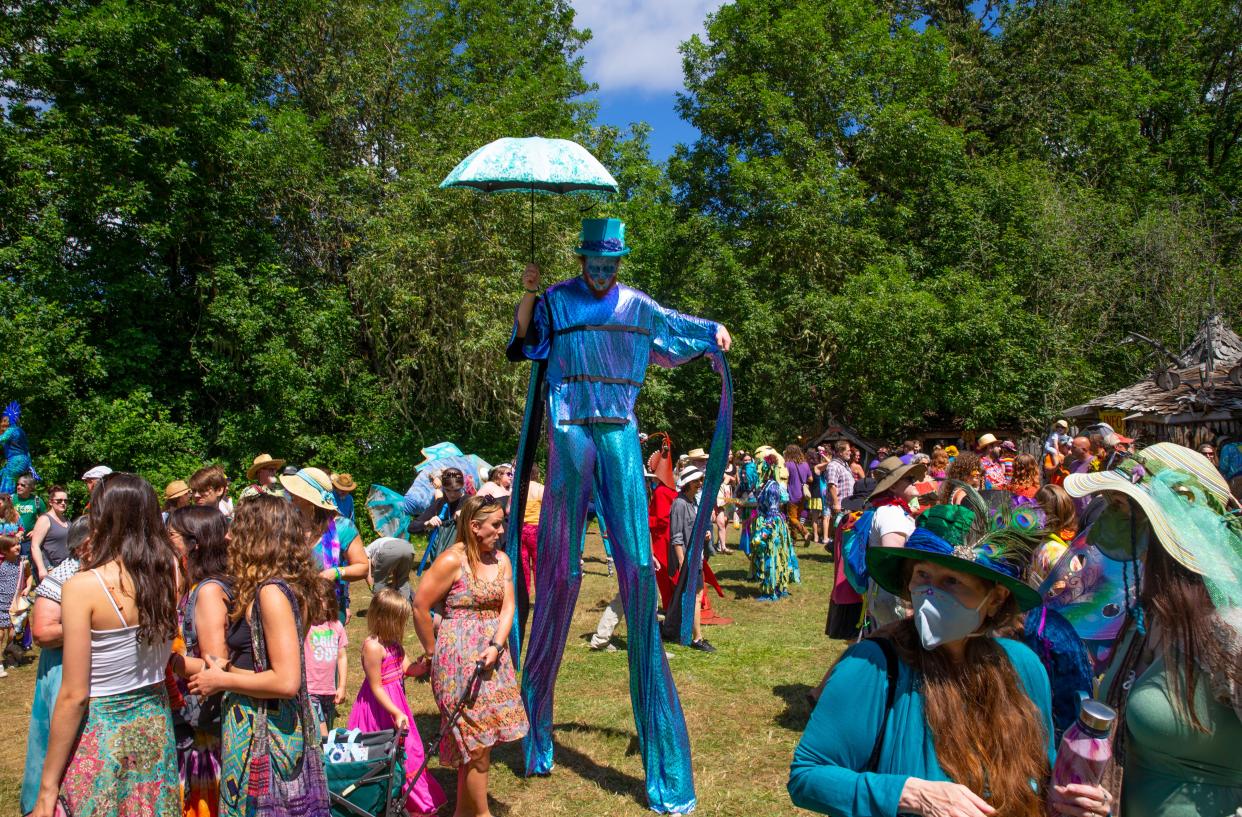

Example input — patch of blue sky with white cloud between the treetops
[571,0,723,160]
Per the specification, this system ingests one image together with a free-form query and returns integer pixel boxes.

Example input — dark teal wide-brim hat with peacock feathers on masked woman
[867,492,1043,611]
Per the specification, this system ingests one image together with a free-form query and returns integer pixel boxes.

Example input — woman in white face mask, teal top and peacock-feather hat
[789,492,1052,817]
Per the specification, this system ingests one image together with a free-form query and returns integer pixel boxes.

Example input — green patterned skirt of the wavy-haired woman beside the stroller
[220,692,308,817]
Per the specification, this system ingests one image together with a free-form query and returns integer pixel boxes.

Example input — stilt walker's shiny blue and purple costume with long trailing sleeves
[508,278,732,813]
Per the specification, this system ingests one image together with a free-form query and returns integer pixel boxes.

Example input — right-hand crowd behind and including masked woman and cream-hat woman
[789,429,1242,817]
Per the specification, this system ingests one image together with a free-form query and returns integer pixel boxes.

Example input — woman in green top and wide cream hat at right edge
[1066,443,1242,817]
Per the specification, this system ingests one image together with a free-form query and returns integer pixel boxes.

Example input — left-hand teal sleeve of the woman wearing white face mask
[789,641,908,817]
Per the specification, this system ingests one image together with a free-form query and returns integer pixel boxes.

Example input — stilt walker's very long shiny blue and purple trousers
[522,412,696,813]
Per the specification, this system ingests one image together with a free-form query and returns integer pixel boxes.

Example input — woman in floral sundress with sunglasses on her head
[414,495,527,817]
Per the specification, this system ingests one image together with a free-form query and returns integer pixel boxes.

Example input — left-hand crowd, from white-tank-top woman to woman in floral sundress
[0,454,527,817]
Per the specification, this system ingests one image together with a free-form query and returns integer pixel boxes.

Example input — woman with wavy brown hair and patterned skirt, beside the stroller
[189,495,327,817]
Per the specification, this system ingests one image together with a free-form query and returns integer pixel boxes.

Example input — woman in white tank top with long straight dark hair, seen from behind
[32,473,181,817]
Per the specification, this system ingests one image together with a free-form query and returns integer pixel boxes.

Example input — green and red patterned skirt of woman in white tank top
[61,683,181,817]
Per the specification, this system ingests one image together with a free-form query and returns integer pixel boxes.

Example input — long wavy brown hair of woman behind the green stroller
[229,494,327,630]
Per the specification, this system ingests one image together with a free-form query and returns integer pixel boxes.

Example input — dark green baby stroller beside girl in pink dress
[324,662,483,817]
